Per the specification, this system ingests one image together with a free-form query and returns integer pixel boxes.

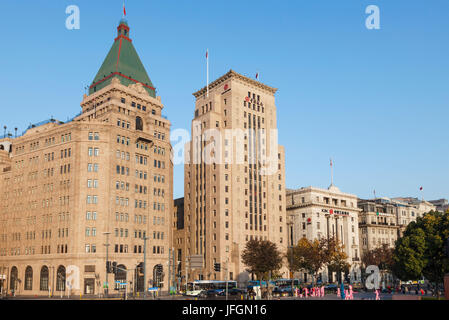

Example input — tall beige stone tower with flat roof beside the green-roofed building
[182,70,287,283]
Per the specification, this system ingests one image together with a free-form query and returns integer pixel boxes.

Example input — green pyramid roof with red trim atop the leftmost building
[89,19,156,98]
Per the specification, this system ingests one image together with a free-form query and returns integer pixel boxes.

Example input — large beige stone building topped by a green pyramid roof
[0,20,173,295]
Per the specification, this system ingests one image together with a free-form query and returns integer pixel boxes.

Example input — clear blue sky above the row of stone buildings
[0,0,449,199]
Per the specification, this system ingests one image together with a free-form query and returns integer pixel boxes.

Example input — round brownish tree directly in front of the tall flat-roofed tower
[242,240,282,280]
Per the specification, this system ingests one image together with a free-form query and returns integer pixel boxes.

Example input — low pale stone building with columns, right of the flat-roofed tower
[287,185,361,282]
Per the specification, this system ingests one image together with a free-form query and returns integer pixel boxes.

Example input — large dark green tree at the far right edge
[393,211,449,297]
